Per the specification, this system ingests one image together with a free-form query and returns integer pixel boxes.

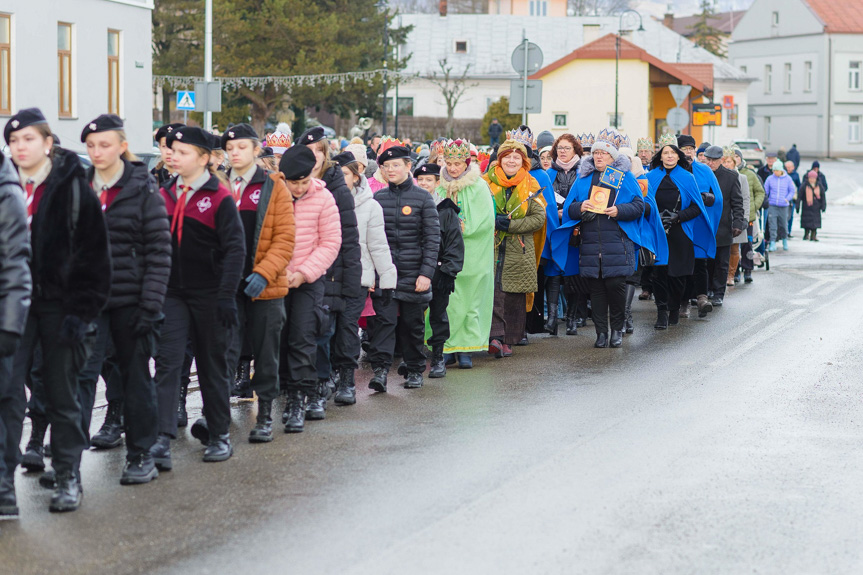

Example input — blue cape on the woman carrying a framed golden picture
[551,168,648,276]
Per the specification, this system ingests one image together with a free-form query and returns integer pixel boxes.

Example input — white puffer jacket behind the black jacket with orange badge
[351,176,398,289]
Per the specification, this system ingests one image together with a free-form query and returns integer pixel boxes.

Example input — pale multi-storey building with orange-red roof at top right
[729,0,863,157]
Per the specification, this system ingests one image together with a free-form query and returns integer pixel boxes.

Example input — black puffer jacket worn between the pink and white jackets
[321,166,363,311]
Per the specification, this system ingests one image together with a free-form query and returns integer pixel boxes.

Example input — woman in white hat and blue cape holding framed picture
[552,128,644,347]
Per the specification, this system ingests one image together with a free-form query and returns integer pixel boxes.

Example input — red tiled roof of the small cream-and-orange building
[530,34,713,92]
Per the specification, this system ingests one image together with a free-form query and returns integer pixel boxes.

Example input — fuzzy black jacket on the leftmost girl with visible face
[30,148,111,322]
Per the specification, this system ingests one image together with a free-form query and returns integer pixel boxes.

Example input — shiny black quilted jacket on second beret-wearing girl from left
[87,161,171,316]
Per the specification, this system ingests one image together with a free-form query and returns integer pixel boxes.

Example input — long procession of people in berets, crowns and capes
[0,108,827,518]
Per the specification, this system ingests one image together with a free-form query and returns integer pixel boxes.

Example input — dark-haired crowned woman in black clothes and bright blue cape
[647,137,716,329]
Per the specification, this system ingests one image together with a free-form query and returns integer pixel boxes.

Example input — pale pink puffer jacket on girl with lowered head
[288,178,342,283]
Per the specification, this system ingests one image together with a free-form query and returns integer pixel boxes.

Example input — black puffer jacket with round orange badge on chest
[375,178,441,303]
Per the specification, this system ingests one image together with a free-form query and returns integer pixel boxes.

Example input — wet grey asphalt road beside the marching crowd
[0,160,863,575]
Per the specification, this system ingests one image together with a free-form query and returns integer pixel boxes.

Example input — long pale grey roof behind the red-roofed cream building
[398,14,750,81]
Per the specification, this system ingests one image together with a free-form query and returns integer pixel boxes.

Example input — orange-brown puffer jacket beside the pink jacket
[252,172,296,300]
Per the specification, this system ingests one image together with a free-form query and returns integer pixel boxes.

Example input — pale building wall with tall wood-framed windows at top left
[0,0,153,152]
